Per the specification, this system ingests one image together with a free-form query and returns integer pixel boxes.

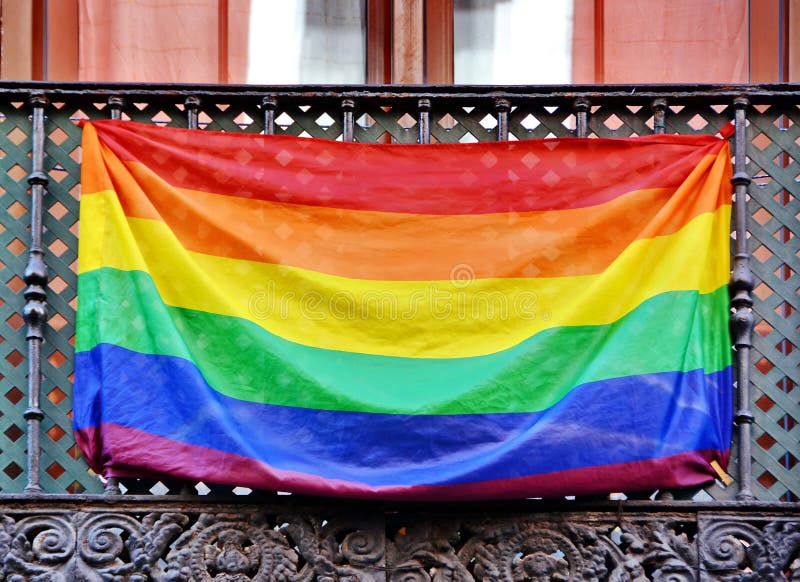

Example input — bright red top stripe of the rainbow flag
[84,120,726,214]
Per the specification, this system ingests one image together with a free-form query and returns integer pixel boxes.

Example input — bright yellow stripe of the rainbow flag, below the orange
[79,196,730,358]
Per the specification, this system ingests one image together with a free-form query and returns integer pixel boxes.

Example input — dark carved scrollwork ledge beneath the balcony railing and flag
[0,495,800,582]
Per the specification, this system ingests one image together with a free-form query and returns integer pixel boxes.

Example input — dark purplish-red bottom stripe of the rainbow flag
[76,424,729,501]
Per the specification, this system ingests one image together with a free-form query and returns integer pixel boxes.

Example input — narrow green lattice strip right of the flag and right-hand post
[748,106,800,501]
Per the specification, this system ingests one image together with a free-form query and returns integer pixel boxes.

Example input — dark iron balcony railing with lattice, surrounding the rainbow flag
[0,84,800,500]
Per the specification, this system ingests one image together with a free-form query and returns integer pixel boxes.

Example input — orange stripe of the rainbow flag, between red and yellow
[84,138,730,281]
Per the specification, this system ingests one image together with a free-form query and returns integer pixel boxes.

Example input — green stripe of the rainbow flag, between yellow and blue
[76,268,731,414]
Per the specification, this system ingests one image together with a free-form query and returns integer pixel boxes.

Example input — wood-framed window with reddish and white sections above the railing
[0,0,800,84]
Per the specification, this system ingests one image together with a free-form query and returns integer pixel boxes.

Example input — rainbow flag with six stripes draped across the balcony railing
[74,121,732,500]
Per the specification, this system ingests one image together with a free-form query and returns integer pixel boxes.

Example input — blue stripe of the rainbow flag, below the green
[74,344,732,486]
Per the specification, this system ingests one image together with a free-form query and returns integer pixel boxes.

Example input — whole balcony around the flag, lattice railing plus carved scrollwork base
[0,83,800,581]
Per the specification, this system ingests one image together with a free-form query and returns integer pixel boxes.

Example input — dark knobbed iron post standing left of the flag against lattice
[23,93,49,493]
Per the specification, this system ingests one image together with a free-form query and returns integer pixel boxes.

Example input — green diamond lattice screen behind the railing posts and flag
[0,85,800,500]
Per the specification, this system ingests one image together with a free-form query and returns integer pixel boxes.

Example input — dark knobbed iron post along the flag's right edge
[729,97,755,501]
